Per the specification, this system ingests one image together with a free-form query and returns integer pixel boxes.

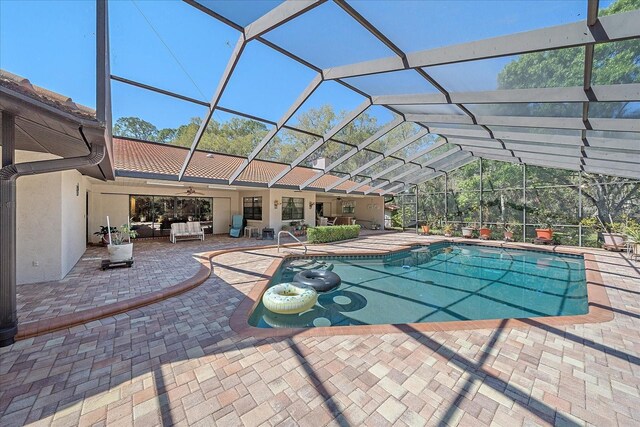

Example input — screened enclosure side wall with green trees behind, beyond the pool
[391,159,640,247]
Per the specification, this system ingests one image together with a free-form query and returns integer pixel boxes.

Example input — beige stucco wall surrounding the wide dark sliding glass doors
[89,179,241,243]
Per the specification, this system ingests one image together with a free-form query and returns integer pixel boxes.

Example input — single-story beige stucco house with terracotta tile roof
[0,66,384,284]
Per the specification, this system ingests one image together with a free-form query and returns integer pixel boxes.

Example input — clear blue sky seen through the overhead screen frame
[0,0,611,132]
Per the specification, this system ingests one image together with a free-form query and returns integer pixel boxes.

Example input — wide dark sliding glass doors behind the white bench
[129,195,213,237]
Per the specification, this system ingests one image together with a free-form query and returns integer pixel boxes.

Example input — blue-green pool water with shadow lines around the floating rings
[249,243,588,328]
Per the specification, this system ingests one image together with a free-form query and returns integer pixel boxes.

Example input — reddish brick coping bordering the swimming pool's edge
[229,238,614,338]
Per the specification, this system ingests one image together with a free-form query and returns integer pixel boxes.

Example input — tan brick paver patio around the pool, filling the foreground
[0,233,640,427]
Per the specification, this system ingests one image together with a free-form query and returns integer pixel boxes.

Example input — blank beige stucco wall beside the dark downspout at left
[1,151,89,284]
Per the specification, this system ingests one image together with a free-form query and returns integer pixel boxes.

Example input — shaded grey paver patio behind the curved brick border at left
[17,236,288,321]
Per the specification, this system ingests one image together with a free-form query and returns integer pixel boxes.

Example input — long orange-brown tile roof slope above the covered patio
[113,137,382,196]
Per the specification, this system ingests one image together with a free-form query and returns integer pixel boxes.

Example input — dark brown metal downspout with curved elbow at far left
[0,133,106,347]
